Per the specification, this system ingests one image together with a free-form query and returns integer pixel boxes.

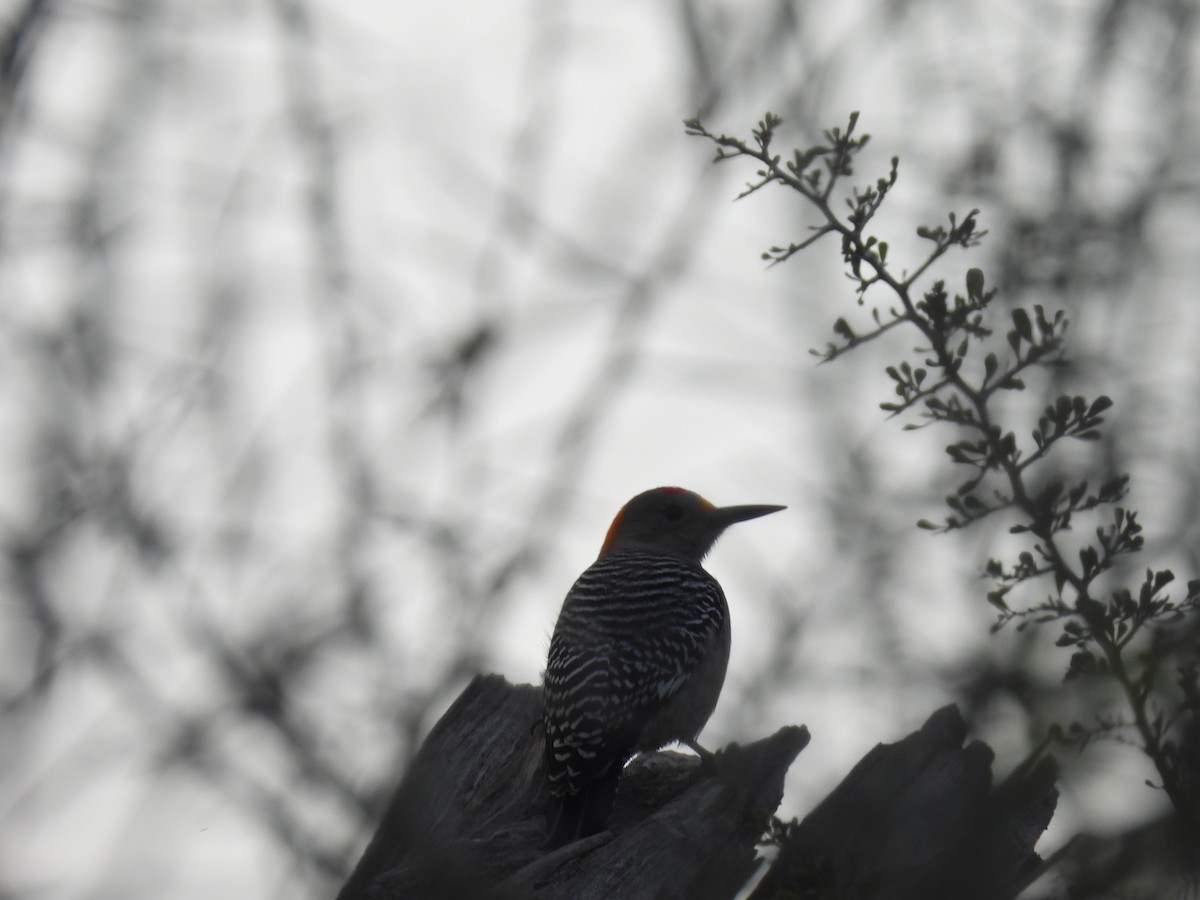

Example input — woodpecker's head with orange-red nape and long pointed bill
[600,487,786,563]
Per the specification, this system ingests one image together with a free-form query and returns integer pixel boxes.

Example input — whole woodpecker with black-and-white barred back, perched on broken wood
[542,487,784,848]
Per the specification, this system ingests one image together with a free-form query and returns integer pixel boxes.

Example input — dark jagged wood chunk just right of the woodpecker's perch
[751,706,1058,900]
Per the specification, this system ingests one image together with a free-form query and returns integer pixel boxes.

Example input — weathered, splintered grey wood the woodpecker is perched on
[338,676,809,900]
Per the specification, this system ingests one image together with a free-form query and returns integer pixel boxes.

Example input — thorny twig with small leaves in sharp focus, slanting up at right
[686,114,1200,828]
